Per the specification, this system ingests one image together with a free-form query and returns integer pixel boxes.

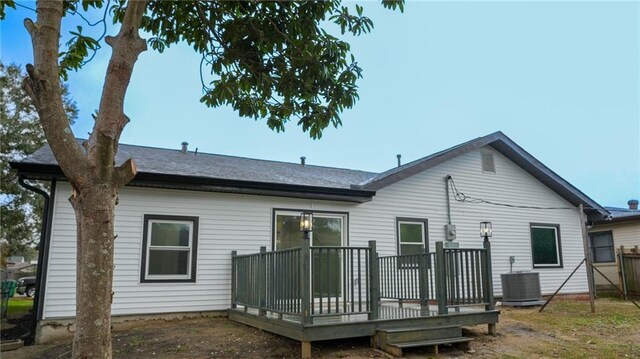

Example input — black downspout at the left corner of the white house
[18,176,56,345]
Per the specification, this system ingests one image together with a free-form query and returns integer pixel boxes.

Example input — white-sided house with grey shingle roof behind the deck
[12,132,608,348]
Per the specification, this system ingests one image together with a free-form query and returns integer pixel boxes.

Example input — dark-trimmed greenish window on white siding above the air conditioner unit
[531,223,562,268]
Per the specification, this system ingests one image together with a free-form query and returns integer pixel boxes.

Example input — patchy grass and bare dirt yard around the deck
[3,299,640,359]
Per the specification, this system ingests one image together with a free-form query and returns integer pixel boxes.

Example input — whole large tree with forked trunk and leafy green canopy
[0,0,403,358]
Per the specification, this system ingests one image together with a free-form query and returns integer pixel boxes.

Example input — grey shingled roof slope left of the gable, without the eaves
[20,144,376,189]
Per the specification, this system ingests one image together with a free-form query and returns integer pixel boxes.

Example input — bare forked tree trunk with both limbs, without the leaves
[23,0,146,358]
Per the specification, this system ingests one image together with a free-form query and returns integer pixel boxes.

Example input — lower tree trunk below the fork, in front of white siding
[70,183,116,358]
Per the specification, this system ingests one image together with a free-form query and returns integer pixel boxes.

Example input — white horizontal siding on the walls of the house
[44,147,587,318]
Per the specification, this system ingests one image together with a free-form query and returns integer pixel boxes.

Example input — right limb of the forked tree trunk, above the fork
[88,1,147,185]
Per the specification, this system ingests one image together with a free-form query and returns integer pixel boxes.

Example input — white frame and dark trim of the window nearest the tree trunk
[142,215,197,282]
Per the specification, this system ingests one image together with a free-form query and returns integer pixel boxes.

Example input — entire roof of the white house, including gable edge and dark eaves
[11,131,609,220]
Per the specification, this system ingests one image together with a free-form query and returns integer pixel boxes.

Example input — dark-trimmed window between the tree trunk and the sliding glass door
[140,215,198,282]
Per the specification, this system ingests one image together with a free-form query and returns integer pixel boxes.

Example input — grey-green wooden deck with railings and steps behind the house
[228,240,499,358]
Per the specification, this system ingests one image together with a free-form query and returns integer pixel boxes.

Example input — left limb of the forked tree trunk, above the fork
[23,0,88,186]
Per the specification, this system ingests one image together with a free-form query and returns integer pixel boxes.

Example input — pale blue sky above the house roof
[1,1,640,207]
